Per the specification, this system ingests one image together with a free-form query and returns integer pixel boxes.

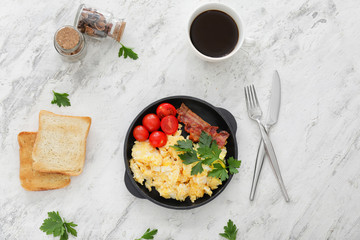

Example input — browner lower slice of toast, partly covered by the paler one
[18,132,70,191]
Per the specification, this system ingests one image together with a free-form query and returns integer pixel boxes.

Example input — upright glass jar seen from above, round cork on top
[54,25,86,62]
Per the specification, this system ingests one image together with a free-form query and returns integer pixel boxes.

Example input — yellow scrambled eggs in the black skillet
[130,130,226,202]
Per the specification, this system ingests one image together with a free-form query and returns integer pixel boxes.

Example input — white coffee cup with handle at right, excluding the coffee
[187,3,255,62]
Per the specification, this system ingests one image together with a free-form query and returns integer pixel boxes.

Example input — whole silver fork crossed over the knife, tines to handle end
[244,85,290,202]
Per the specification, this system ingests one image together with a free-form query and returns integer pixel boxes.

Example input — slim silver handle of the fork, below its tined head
[257,121,290,202]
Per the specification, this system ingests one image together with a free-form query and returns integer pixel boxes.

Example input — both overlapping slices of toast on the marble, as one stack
[18,110,91,191]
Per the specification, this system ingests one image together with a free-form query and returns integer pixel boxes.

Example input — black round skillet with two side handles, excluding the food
[124,96,238,209]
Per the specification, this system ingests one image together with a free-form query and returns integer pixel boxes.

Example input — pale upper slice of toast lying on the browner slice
[32,110,91,176]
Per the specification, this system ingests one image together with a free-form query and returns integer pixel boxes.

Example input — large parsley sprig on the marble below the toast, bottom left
[40,212,77,240]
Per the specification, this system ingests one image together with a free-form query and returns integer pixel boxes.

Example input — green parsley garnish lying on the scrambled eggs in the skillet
[172,131,241,181]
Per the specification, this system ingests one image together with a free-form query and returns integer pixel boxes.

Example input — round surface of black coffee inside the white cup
[190,10,239,57]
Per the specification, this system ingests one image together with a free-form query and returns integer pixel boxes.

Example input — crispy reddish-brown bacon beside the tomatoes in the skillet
[177,103,230,148]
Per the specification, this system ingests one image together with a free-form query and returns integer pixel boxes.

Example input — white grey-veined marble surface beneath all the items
[0,0,360,240]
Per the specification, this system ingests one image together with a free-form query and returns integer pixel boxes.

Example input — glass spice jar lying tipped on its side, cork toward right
[74,4,126,42]
